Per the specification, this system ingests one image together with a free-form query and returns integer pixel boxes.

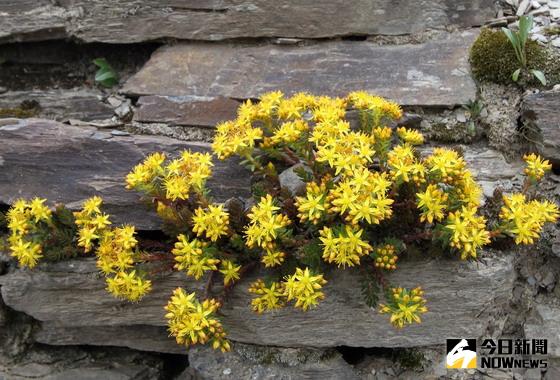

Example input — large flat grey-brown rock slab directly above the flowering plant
[122,32,482,106]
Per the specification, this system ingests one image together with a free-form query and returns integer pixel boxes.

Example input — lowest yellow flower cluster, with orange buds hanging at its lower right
[165,288,231,352]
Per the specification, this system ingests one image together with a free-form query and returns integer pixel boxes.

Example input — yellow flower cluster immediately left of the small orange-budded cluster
[320,225,373,267]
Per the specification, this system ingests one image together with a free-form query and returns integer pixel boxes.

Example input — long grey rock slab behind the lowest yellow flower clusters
[0,255,514,352]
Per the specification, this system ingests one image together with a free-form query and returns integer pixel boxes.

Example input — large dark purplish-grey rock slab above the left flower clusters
[0,119,250,229]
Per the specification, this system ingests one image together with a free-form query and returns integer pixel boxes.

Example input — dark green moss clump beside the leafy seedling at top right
[470,29,560,84]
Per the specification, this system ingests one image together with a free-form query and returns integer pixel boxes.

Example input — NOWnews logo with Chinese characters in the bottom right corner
[446,339,548,369]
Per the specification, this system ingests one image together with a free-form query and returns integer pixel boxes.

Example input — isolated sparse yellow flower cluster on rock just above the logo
[379,287,428,328]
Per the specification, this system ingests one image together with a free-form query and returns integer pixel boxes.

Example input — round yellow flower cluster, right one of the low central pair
[283,268,327,311]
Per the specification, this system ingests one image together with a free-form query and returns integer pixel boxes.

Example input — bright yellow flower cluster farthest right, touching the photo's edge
[500,194,560,244]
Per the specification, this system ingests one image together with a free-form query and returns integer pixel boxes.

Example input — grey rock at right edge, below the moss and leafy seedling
[521,91,560,168]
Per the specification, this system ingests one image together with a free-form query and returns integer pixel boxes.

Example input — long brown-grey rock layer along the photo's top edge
[0,0,495,43]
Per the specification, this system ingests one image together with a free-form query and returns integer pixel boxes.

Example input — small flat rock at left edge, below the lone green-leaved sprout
[0,88,113,121]
